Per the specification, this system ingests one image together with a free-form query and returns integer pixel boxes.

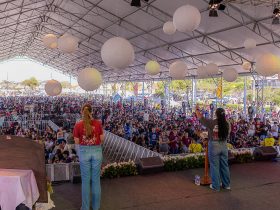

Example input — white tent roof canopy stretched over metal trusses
[0,0,280,82]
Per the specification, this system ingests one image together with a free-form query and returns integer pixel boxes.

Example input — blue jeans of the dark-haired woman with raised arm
[208,141,230,191]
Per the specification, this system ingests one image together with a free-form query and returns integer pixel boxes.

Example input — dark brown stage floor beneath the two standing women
[52,162,280,210]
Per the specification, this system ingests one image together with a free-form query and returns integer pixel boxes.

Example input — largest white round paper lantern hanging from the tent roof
[101,37,135,69]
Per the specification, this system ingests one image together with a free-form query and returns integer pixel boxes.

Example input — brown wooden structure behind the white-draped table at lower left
[0,136,48,203]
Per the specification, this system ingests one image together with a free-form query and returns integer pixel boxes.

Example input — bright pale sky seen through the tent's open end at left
[0,58,76,84]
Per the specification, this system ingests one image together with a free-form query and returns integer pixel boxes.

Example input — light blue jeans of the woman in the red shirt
[80,146,102,210]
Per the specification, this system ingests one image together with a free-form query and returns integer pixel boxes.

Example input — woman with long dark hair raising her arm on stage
[196,106,230,191]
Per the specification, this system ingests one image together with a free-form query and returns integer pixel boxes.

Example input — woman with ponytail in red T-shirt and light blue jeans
[73,104,104,210]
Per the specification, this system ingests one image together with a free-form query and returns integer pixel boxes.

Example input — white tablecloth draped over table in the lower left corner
[0,169,40,210]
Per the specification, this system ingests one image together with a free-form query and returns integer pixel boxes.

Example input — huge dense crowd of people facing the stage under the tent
[0,96,280,160]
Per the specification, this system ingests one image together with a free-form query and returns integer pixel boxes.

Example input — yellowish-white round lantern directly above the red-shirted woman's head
[78,68,102,91]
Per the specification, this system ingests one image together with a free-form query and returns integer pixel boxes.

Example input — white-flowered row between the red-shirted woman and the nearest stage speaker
[101,160,137,179]
